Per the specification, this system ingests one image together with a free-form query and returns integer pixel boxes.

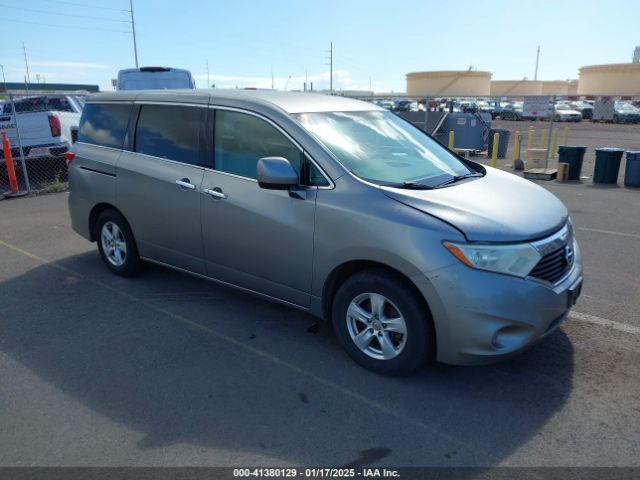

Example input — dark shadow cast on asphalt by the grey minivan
[0,253,573,466]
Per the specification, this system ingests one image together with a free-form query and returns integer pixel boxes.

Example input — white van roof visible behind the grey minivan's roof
[116,67,196,90]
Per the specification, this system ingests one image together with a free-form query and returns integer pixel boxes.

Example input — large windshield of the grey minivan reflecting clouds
[295,111,474,186]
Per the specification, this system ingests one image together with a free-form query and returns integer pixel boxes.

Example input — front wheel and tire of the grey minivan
[332,269,435,375]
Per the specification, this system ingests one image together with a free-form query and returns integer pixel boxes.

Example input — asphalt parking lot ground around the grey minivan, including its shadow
[0,178,640,467]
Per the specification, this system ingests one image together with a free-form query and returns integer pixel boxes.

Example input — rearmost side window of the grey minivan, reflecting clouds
[78,103,131,148]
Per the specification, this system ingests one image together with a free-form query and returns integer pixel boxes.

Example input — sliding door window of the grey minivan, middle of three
[134,105,205,165]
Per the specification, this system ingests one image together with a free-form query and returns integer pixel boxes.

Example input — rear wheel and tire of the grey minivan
[95,210,141,277]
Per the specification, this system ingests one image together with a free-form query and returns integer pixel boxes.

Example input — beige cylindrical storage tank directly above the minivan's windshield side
[407,69,491,97]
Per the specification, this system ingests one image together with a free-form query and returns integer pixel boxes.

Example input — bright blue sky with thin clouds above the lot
[0,0,640,92]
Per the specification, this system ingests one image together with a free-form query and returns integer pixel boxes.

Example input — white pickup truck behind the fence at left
[0,95,84,160]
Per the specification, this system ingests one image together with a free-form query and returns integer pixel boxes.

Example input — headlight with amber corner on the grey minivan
[443,242,542,277]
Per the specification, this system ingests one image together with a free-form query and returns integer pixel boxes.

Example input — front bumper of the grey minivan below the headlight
[414,243,582,365]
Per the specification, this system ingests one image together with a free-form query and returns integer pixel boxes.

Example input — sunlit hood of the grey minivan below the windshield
[381,167,568,242]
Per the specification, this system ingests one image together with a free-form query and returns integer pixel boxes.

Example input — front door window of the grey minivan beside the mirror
[214,110,302,178]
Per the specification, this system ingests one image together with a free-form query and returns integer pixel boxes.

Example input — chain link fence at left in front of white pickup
[0,94,84,195]
